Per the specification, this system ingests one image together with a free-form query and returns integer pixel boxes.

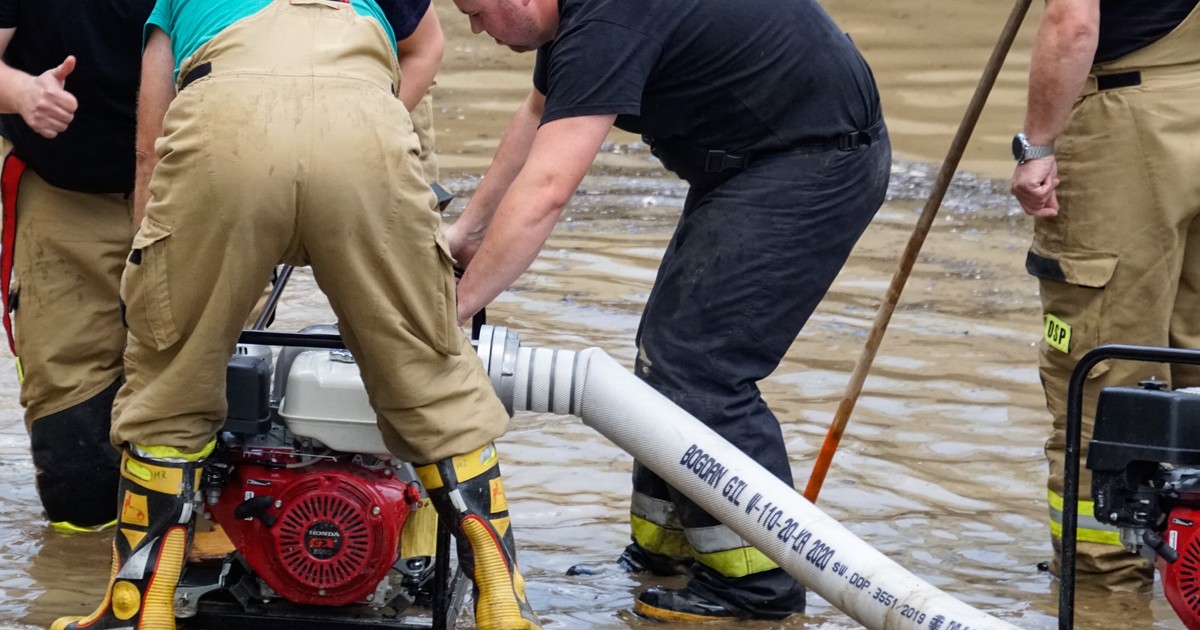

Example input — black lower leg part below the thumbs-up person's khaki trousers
[29,380,121,530]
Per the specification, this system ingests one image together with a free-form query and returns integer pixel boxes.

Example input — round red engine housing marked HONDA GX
[209,462,420,606]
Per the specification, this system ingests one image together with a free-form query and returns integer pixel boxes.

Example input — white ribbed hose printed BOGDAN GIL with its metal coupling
[479,326,1016,630]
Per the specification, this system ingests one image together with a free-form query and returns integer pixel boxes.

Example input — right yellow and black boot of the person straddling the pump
[416,444,541,630]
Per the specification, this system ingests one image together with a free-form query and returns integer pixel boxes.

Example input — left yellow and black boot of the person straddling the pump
[50,444,211,630]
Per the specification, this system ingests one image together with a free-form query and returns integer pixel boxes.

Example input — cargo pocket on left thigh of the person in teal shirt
[121,217,179,350]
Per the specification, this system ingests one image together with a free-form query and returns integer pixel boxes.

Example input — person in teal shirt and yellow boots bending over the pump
[53,0,539,630]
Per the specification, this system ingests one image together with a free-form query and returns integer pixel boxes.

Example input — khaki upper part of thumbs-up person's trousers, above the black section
[0,138,133,428]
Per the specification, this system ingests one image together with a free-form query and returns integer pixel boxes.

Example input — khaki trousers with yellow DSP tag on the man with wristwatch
[1026,10,1200,590]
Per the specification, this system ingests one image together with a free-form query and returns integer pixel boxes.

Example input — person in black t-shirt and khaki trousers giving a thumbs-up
[0,0,154,530]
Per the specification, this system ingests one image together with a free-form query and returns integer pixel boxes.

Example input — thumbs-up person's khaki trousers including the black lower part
[0,148,133,530]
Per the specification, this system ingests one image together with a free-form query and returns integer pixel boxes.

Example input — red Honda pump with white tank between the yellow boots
[174,325,469,630]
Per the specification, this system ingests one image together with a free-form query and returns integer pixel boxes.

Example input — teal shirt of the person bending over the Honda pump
[145,0,396,78]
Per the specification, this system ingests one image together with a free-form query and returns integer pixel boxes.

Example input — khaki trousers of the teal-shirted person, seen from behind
[113,0,509,463]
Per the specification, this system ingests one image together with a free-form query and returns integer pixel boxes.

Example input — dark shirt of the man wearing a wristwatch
[1096,0,1196,64]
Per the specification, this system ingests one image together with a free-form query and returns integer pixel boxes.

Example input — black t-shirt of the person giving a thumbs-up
[0,0,154,192]
